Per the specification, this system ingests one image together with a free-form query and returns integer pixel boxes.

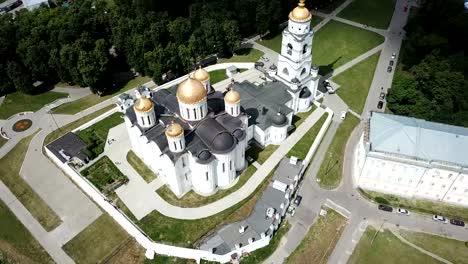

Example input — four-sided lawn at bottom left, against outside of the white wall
[63,214,129,263]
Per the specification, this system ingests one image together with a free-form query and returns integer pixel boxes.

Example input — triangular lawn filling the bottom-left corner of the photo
[0,200,54,263]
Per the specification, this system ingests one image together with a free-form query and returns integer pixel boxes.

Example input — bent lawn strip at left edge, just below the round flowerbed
[0,132,62,231]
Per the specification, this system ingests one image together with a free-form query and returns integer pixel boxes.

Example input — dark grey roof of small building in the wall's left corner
[47,132,88,162]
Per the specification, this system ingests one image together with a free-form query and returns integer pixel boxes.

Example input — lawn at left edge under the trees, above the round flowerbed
[0,91,68,119]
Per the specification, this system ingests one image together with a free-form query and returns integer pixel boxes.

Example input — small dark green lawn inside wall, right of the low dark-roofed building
[76,112,123,159]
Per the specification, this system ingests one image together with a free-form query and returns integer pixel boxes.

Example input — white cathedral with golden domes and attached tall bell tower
[118,0,319,197]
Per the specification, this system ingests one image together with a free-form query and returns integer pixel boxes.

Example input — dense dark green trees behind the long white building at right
[387,0,468,126]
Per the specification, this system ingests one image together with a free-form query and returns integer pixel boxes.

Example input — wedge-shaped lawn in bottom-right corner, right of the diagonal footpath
[400,230,468,264]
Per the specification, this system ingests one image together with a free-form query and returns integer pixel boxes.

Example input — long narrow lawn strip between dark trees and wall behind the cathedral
[52,76,151,115]
